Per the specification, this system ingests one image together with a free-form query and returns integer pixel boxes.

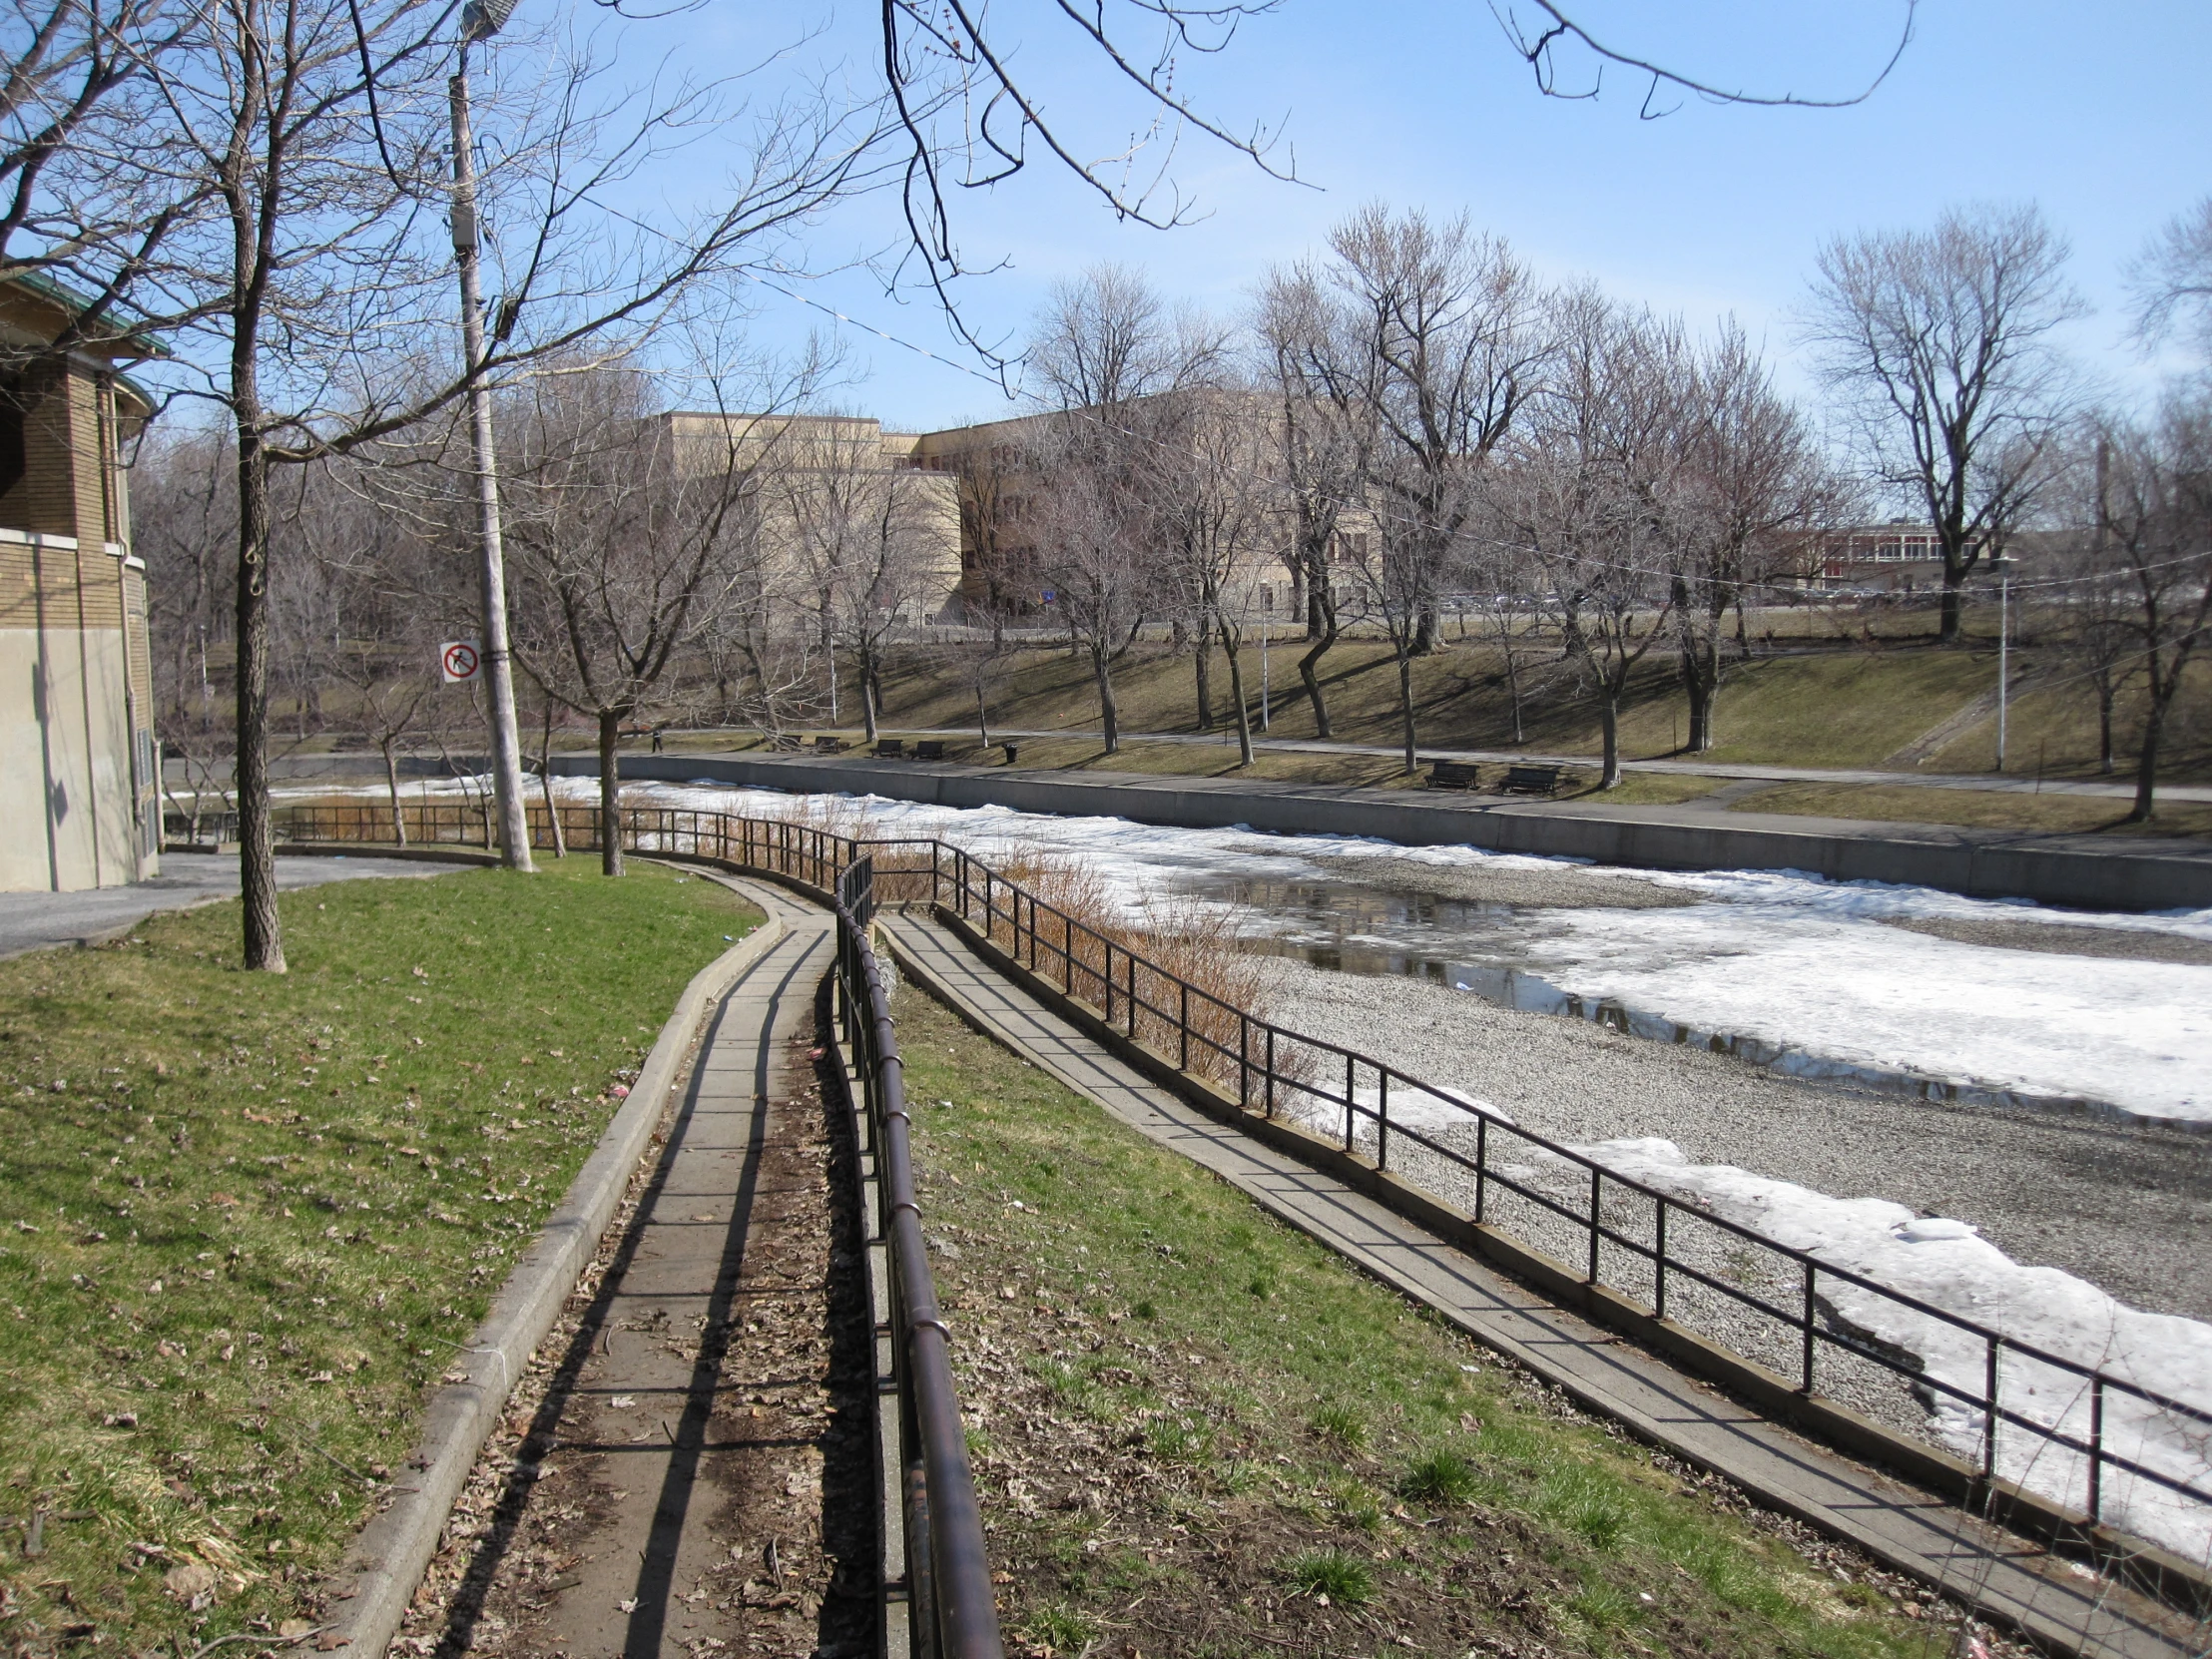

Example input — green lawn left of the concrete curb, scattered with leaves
[0,858,759,1652]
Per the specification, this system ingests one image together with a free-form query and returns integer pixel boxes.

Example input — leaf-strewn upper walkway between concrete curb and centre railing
[411,880,848,1659]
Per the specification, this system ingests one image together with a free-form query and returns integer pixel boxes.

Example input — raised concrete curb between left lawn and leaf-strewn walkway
[318,918,790,1659]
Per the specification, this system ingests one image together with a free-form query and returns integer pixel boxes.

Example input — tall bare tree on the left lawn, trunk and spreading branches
[104,0,876,971]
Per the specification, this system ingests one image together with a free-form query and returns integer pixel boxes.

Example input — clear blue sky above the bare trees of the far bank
[688,0,2212,427]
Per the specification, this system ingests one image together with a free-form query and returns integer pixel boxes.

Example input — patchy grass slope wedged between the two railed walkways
[900,991,1990,1659]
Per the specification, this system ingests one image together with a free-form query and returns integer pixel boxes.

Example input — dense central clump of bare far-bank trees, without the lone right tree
[982,208,1852,783]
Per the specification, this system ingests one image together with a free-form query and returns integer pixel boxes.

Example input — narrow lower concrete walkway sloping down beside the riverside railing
[882,915,2203,1659]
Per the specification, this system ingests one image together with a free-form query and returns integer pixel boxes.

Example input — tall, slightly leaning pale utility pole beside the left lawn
[449,0,535,871]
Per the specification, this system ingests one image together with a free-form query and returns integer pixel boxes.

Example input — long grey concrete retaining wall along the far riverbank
[553,755,2212,911]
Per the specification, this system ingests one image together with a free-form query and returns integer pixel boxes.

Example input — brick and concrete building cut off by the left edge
[0,276,162,891]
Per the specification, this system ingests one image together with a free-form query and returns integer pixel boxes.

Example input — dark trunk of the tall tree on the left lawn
[233,435,285,973]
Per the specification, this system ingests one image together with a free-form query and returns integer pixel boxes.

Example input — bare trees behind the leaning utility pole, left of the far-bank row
[140,360,951,867]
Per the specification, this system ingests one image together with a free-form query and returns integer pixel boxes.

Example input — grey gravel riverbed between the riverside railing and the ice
[1274,960,2212,1319]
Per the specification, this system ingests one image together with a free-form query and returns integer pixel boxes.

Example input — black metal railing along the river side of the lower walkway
[259,808,2212,1574]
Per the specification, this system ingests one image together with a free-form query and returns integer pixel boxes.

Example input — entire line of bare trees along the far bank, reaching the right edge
[969,193,2212,817]
